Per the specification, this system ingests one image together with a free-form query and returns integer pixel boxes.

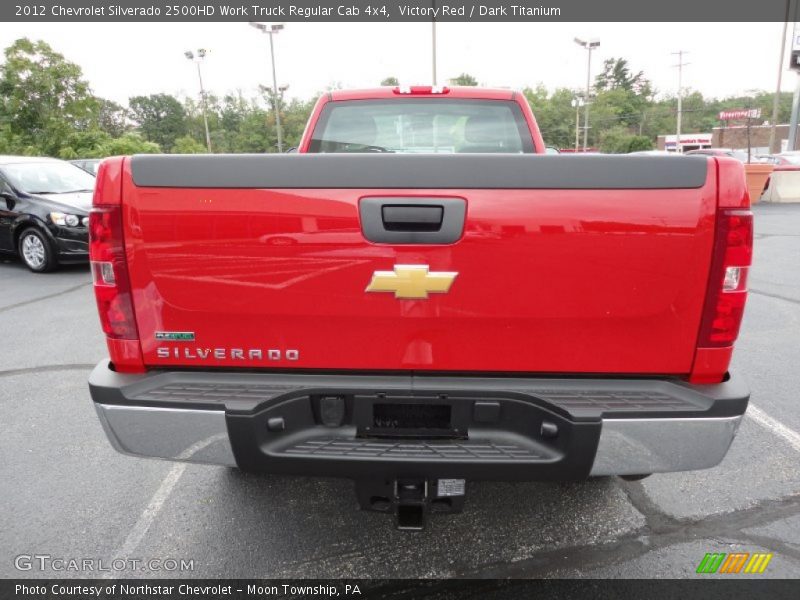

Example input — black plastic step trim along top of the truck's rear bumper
[89,361,750,422]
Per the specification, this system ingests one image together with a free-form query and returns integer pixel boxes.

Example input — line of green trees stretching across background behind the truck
[0,38,791,159]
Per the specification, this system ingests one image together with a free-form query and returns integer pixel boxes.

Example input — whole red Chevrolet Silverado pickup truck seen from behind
[89,88,752,528]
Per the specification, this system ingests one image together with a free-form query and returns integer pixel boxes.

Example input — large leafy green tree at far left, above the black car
[0,38,99,155]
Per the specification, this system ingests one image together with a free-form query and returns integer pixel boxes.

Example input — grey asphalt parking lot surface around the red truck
[0,205,800,578]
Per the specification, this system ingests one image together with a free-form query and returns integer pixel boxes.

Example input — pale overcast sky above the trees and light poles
[0,22,797,103]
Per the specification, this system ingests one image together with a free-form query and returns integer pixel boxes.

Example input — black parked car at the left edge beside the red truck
[0,156,95,273]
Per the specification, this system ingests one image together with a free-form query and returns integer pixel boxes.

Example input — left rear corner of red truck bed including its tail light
[89,158,144,373]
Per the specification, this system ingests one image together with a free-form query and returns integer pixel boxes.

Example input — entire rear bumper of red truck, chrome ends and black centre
[90,363,749,480]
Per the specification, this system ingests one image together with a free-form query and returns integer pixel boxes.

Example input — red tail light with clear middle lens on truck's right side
[697,209,753,348]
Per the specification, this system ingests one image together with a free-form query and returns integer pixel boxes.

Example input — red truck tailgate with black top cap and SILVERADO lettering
[122,155,717,374]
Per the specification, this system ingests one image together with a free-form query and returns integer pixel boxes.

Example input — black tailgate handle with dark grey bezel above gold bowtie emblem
[359,197,467,244]
